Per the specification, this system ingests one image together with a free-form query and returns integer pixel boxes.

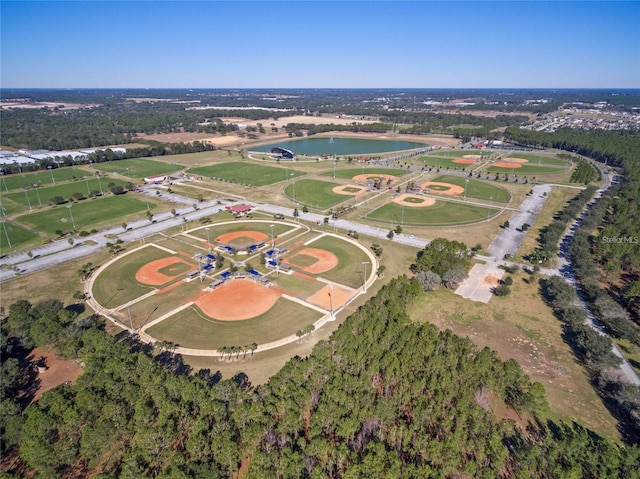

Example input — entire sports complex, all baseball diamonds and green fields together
[0,137,570,356]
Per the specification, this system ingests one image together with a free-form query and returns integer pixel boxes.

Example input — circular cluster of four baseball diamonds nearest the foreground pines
[86,220,377,355]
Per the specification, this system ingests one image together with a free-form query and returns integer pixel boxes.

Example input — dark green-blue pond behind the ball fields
[250,137,428,156]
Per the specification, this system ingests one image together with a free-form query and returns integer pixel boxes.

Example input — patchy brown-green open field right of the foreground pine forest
[410,272,619,438]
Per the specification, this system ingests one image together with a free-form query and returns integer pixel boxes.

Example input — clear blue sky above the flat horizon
[0,0,640,88]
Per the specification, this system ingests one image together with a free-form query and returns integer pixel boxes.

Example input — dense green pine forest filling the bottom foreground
[3,277,640,479]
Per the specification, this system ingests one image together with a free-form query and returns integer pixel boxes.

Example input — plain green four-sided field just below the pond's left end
[189,161,306,186]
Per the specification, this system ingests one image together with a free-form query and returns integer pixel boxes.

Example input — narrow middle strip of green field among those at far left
[5,177,126,211]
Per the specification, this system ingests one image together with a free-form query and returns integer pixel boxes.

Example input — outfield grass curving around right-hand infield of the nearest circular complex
[293,236,371,288]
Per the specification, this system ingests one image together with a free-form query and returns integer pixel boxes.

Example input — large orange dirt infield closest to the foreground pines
[195,279,280,321]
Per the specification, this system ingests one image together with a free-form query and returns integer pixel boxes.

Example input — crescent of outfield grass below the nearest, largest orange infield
[147,298,322,354]
